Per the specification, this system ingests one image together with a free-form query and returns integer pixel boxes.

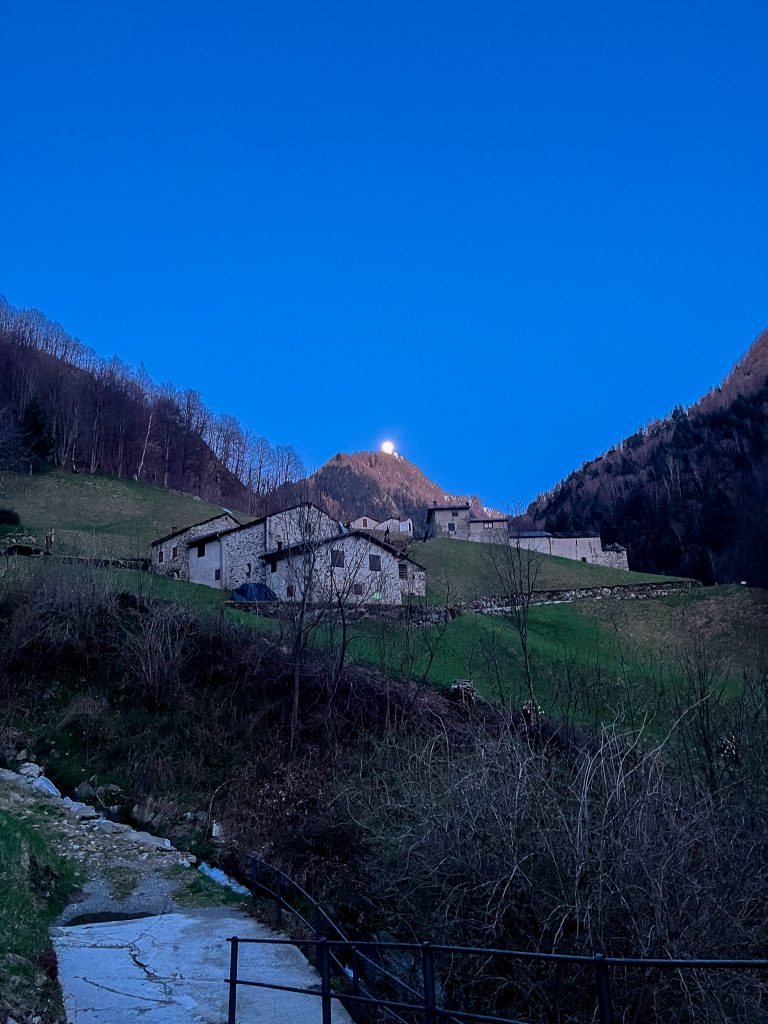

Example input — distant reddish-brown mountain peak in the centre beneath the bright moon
[267,452,493,529]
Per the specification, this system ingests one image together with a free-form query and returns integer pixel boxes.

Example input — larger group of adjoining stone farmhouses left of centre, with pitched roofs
[151,502,425,604]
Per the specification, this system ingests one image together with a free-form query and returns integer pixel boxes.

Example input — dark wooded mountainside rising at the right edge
[528,332,768,586]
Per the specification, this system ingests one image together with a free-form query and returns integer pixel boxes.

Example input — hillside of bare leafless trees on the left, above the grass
[0,298,304,511]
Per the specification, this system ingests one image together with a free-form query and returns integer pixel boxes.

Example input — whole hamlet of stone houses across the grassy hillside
[151,502,628,605]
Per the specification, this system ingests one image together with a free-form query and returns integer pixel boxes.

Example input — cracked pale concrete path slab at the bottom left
[52,908,351,1024]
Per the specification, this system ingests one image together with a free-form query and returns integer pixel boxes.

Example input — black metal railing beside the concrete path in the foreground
[227,858,768,1024]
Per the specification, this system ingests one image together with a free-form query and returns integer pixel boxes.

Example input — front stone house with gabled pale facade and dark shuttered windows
[261,530,426,605]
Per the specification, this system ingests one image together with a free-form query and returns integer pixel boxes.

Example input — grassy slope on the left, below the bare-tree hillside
[0,470,247,558]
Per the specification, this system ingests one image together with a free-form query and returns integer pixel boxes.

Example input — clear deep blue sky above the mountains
[0,0,768,507]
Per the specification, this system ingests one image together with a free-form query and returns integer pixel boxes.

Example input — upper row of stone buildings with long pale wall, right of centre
[427,502,629,569]
